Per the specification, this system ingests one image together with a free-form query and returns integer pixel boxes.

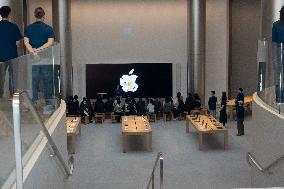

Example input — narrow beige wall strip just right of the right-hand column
[205,0,229,102]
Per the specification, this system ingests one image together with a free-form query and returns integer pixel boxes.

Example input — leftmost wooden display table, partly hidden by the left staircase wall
[66,117,81,154]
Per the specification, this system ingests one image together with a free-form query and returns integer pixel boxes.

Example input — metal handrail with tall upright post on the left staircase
[12,91,71,189]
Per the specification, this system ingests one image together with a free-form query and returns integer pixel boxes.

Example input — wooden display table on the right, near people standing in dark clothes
[186,115,228,150]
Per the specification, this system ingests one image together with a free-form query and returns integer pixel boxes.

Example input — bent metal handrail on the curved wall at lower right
[247,152,284,174]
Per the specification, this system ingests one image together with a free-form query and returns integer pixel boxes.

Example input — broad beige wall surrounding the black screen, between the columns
[71,0,187,99]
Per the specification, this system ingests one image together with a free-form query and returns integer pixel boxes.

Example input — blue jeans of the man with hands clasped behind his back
[32,65,53,104]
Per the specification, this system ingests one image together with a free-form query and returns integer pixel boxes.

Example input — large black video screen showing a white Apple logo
[86,63,172,98]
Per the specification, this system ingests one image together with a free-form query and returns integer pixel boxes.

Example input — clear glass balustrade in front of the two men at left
[0,44,60,188]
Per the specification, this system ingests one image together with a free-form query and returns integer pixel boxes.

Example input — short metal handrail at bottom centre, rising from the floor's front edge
[147,152,164,189]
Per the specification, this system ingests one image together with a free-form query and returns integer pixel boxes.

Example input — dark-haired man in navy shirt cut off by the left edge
[0,6,22,98]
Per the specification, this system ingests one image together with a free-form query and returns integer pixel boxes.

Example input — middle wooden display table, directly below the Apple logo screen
[121,116,152,153]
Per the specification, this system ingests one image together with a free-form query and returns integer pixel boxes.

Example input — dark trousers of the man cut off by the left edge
[0,61,14,97]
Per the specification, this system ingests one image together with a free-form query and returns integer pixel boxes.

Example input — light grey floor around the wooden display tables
[68,117,252,189]
